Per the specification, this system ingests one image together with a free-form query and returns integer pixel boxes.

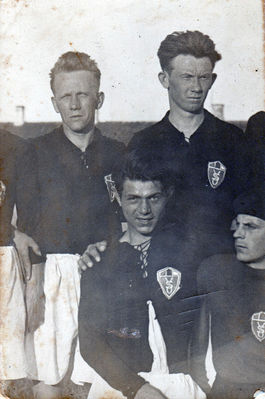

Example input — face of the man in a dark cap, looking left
[231,214,265,267]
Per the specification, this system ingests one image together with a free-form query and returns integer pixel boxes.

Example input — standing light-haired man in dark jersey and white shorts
[17,52,123,399]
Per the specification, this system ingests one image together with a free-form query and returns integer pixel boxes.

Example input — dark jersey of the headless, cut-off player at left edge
[0,130,36,245]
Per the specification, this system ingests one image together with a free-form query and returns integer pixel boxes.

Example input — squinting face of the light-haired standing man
[52,71,103,133]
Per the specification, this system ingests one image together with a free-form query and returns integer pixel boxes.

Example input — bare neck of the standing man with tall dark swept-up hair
[168,108,204,139]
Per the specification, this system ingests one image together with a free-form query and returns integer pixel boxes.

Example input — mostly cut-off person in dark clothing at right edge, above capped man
[243,111,265,187]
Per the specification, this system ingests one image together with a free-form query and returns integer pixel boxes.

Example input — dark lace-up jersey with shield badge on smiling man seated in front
[78,227,199,397]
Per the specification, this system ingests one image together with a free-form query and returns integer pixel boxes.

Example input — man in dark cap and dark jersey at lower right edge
[192,188,265,399]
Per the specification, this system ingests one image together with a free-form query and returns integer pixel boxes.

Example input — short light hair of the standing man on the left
[50,51,101,91]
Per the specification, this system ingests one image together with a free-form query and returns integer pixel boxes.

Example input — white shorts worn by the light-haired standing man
[29,254,80,385]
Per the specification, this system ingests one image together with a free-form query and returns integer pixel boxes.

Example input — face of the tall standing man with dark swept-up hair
[162,54,214,113]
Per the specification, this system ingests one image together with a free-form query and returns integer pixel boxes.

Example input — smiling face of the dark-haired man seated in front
[121,179,167,242]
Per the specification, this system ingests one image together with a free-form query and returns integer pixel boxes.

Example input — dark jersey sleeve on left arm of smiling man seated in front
[78,265,145,398]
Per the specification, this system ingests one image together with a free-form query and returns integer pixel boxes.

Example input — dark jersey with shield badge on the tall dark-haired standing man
[128,110,249,253]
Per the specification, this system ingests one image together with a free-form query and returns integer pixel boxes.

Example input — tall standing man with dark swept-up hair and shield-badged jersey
[129,31,248,256]
